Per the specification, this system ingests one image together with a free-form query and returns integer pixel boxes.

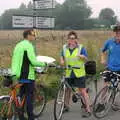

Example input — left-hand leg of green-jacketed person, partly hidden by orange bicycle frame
[18,85,25,120]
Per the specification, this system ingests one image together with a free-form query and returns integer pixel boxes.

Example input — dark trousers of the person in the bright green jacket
[19,82,35,120]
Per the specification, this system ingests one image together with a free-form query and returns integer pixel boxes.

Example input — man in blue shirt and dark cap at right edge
[97,24,120,111]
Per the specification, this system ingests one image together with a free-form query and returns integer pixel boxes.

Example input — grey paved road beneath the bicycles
[36,80,120,120]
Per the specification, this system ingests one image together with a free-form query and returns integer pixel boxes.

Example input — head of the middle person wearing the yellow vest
[68,31,78,47]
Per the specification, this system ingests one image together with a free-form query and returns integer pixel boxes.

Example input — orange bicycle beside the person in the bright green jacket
[0,70,46,120]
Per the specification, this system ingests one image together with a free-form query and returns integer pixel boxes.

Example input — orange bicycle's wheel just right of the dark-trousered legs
[33,85,47,118]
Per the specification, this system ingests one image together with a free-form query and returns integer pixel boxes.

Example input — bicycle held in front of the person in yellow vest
[54,66,89,120]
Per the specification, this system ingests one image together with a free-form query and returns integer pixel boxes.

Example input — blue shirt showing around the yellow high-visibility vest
[61,47,88,78]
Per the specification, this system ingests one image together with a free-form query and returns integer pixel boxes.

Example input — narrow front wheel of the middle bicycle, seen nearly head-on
[54,84,65,120]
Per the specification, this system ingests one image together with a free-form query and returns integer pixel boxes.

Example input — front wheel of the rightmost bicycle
[93,86,115,118]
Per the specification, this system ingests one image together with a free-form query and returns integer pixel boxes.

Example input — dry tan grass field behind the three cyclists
[0,30,112,67]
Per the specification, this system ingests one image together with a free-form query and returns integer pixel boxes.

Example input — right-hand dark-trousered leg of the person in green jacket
[26,82,35,120]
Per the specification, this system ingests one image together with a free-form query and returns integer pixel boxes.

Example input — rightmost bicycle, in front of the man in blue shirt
[93,71,120,118]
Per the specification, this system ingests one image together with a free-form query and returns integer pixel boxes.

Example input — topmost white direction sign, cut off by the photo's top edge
[34,0,55,9]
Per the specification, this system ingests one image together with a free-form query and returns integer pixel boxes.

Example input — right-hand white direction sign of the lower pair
[36,17,55,28]
